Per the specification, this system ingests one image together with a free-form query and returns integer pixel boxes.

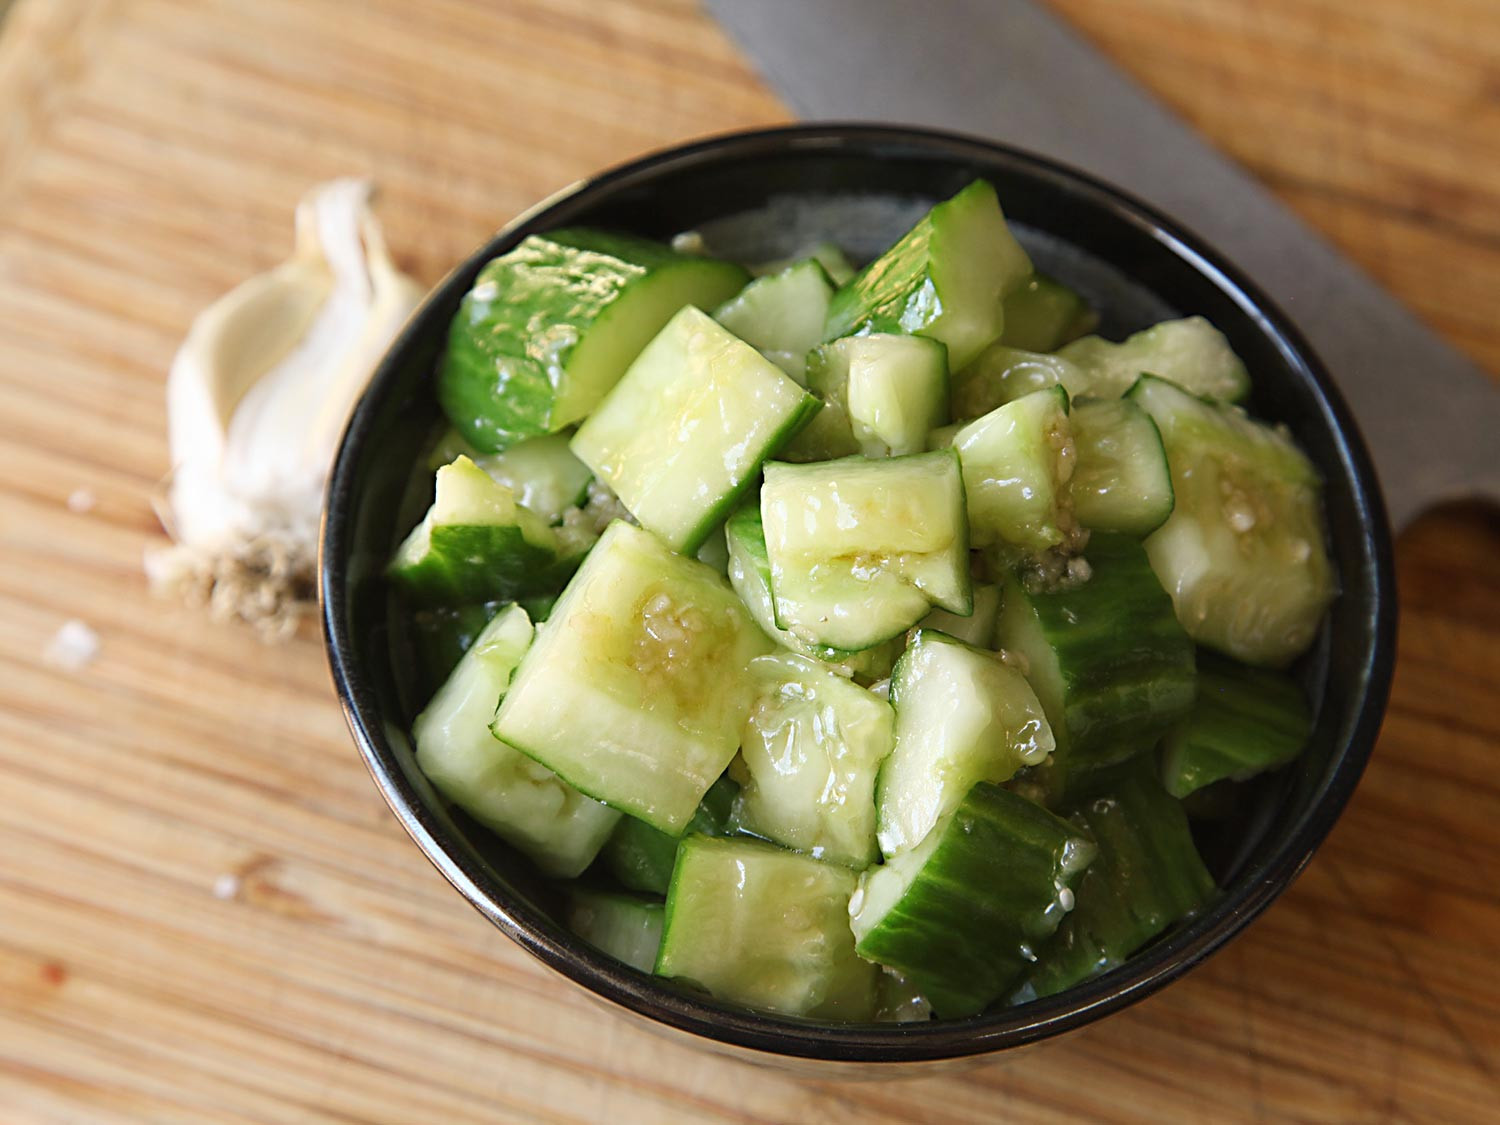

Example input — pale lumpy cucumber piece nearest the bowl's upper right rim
[1058,317,1250,402]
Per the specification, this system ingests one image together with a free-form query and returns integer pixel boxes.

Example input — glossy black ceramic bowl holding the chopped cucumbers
[321,126,1395,1062]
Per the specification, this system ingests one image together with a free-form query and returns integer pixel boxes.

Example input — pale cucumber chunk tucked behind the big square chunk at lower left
[413,606,620,878]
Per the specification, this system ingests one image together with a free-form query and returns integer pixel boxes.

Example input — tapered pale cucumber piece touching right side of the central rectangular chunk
[953,387,1079,557]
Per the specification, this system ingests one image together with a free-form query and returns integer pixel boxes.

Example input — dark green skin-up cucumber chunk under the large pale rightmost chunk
[1161,653,1313,797]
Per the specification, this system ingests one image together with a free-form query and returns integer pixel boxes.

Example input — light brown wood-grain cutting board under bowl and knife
[0,0,1500,1124]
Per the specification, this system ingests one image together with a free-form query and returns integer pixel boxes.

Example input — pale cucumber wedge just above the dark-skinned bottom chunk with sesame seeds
[878,629,1055,857]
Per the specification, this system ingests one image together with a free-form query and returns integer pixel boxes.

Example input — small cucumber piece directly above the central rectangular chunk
[788,333,948,461]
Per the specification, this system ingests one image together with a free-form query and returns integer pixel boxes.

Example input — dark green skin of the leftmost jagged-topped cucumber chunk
[387,525,582,606]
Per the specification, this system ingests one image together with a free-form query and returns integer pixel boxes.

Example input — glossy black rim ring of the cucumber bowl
[318,122,1397,1064]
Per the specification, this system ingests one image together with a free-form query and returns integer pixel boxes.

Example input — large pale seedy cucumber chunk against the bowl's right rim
[1130,377,1337,668]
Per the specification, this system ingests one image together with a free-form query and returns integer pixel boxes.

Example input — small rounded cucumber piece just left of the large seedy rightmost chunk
[1068,399,1173,537]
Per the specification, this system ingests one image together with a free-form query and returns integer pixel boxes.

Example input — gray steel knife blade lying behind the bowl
[705,0,1500,530]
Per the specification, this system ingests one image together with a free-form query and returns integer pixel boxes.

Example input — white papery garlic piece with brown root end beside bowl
[146,179,425,639]
